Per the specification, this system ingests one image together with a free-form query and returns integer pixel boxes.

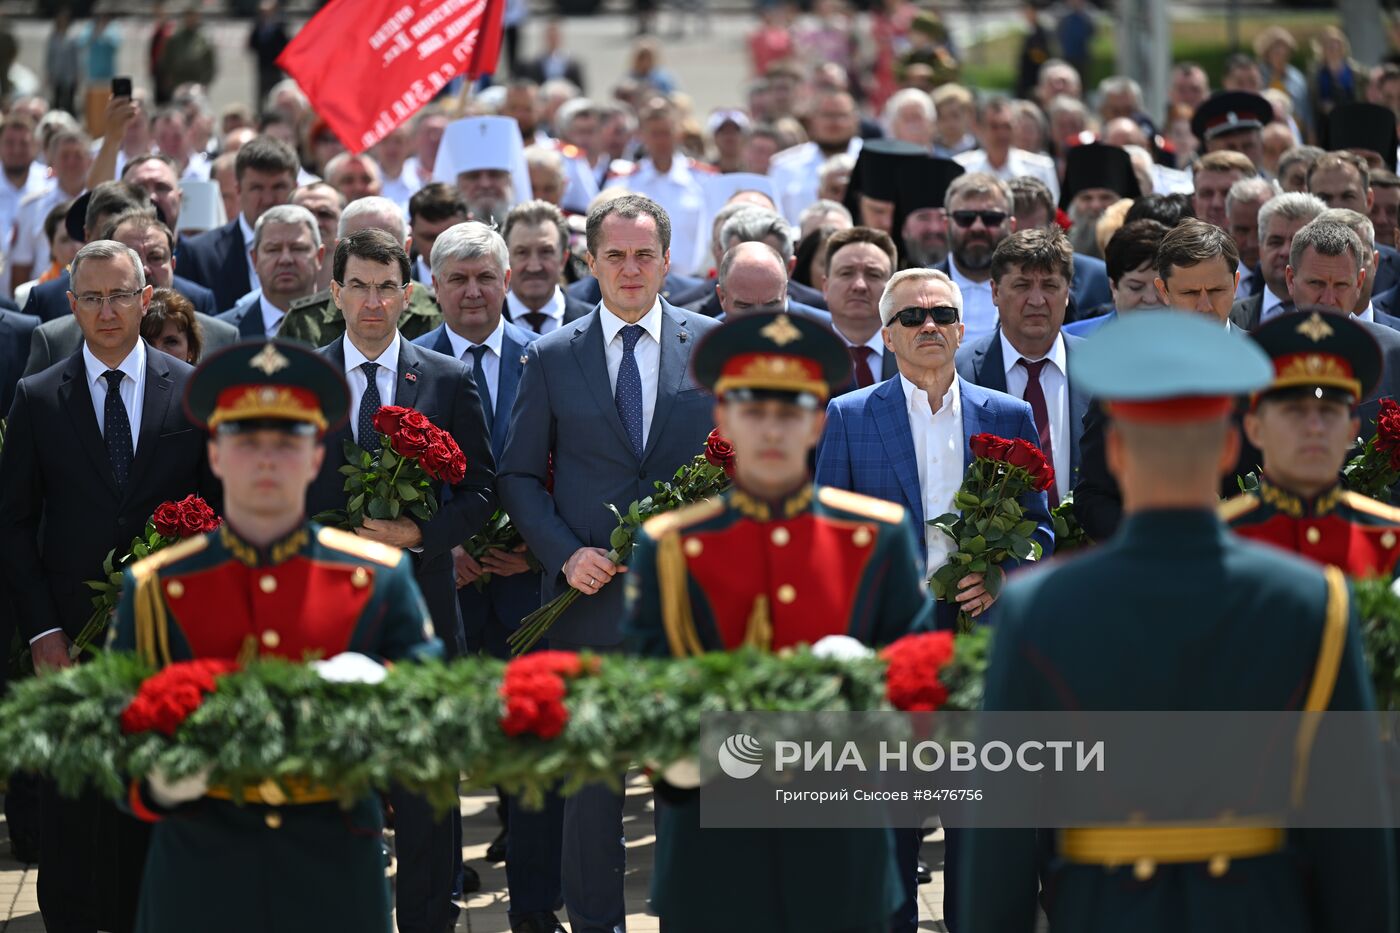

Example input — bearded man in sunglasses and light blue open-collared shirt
[938,172,1016,340]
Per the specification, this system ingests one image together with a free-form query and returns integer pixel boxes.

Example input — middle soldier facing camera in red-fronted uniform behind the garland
[624,314,932,933]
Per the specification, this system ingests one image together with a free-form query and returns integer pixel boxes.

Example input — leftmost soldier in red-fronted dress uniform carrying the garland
[112,340,440,933]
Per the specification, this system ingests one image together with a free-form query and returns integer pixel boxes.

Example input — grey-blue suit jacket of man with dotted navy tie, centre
[496,301,718,647]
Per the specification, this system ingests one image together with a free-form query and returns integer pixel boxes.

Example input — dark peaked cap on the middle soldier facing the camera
[694,311,851,408]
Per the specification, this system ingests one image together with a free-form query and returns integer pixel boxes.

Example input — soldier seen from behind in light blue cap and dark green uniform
[958,311,1396,933]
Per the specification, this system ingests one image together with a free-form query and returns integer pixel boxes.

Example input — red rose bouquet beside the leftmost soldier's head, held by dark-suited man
[315,405,466,528]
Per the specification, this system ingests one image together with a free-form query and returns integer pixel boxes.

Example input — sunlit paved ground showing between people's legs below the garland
[0,780,944,933]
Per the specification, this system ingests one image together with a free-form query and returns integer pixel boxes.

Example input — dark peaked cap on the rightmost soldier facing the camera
[1254,311,1383,405]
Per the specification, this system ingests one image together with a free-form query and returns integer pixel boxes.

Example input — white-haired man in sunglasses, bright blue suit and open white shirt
[816,269,1054,933]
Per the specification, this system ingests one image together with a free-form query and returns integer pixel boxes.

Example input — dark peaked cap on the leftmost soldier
[185,340,350,434]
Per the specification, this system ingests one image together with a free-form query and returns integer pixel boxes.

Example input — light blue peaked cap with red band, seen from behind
[1074,311,1274,423]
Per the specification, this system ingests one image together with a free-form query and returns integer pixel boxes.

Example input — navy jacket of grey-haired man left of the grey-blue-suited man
[414,321,539,653]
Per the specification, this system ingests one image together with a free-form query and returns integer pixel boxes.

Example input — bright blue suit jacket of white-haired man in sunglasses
[816,375,1054,626]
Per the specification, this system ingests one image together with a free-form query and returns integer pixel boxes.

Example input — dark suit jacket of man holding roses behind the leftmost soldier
[307,336,496,657]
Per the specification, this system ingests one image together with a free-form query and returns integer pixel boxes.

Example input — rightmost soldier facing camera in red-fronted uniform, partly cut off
[1219,311,1400,577]
